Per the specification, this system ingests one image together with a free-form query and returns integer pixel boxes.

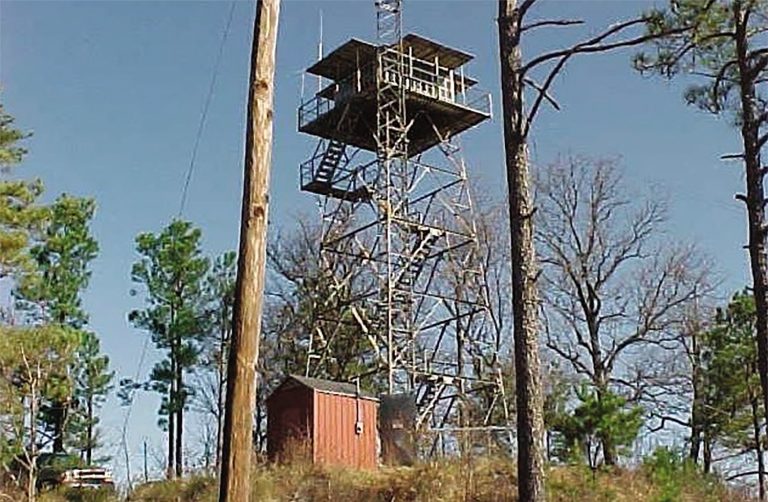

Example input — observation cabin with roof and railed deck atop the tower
[298,34,491,198]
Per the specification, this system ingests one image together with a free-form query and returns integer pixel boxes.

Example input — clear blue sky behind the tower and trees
[0,0,747,482]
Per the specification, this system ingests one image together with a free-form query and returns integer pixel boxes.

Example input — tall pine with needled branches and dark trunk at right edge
[635,0,768,466]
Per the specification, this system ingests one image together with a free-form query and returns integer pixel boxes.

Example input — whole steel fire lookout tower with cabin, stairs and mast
[298,0,508,440]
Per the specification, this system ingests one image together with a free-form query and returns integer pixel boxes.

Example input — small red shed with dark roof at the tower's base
[267,375,378,469]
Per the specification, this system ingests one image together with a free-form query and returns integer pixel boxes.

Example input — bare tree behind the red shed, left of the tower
[263,220,375,378]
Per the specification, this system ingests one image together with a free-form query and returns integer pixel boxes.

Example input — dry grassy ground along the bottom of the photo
[24,455,752,502]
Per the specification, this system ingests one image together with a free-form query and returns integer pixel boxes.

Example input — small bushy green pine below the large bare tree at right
[551,386,643,468]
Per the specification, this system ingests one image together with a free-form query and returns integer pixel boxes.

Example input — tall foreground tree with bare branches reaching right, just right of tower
[498,0,688,494]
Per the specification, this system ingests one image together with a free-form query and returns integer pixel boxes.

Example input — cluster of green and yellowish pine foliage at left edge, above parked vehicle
[0,92,112,492]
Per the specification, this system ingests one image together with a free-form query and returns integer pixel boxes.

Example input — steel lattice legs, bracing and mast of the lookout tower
[302,0,509,438]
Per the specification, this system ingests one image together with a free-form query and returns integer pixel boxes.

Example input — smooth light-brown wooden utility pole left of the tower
[219,0,280,502]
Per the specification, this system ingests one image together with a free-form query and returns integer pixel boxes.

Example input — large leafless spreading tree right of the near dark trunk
[536,157,711,465]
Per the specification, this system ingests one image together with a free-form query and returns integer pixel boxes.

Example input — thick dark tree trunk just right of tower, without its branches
[499,0,545,502]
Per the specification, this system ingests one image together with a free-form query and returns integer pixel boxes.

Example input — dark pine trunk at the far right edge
[733,1,768,448]
